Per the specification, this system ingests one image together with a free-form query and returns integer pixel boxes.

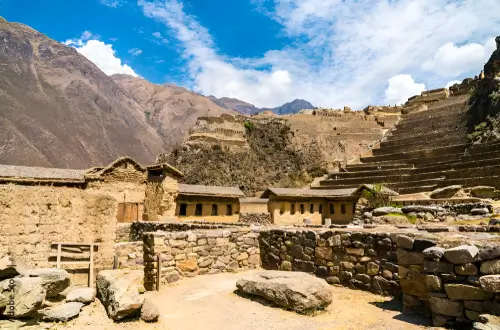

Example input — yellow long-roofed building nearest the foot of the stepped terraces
[261,188,359,225]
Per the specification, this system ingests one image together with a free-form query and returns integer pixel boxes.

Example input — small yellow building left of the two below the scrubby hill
[175,184,245,222]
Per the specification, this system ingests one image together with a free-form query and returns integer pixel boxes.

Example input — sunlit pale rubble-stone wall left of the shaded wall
[143,228,260,290]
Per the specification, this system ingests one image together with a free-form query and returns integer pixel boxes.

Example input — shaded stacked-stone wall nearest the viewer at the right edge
[397,235,500,328]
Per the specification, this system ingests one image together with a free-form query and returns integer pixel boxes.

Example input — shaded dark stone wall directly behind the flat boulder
[259,229,400,296]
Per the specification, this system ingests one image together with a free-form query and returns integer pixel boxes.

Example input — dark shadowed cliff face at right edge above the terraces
[469,36,500,143]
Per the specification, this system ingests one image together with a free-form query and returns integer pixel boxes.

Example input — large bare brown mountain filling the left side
[0,17,163,168]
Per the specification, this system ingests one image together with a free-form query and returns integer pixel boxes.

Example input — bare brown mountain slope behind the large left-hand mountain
[112,74,236,150]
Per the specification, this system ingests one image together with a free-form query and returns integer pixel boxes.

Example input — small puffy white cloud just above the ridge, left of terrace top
[384,74,425,105]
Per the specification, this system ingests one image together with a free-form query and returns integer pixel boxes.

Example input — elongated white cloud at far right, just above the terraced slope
[422,38,496,77]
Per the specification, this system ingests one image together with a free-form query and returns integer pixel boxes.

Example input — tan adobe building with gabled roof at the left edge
[0,157,183,282]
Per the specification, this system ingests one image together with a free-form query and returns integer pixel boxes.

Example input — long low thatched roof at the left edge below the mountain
[0,165,85,183]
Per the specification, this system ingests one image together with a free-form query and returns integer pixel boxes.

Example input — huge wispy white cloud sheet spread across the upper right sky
[138,0,500,109]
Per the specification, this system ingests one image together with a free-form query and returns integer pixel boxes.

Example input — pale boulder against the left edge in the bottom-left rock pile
[0,277,45,318]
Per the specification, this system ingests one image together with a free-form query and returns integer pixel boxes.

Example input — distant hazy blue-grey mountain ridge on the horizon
[208,95,315,115]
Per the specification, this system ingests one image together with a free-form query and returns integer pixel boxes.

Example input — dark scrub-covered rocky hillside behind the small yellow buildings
[159,120,327,195]
